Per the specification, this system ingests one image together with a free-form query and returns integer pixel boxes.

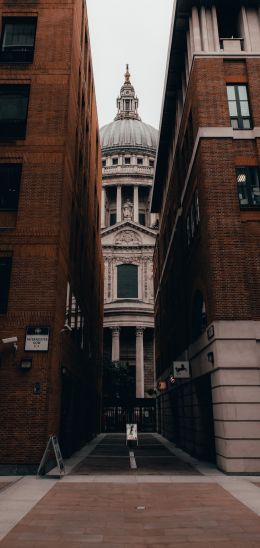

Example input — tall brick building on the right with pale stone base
[152,0,260,472]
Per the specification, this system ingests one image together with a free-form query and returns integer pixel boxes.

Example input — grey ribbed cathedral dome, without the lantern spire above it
[100,118,158,152]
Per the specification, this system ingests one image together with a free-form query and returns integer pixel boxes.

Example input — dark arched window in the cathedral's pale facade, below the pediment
[117,264,138,299]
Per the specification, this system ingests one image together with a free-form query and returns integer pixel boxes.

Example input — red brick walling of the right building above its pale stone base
[155,58,260,372]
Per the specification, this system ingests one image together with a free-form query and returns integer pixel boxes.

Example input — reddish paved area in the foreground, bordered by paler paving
[0,482,260,548]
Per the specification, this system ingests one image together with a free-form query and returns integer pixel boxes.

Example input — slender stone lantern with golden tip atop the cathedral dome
[115,65,141,120]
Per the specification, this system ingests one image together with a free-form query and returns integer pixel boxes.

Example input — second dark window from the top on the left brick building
[0,84,30,141]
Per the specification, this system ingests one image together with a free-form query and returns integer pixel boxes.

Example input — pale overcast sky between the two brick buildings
[86,0,174,128]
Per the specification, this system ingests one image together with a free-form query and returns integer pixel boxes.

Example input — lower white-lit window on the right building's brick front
[236,166,260,208]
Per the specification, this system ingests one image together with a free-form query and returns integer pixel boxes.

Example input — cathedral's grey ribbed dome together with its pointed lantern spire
[100,65,158,153]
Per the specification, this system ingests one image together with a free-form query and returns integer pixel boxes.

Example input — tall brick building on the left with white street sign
[0,0,103,471]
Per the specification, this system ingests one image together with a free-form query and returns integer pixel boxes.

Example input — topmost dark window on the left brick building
[0,17,37,63]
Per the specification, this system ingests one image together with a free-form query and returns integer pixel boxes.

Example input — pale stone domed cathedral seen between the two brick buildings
[100,66,157,399]
